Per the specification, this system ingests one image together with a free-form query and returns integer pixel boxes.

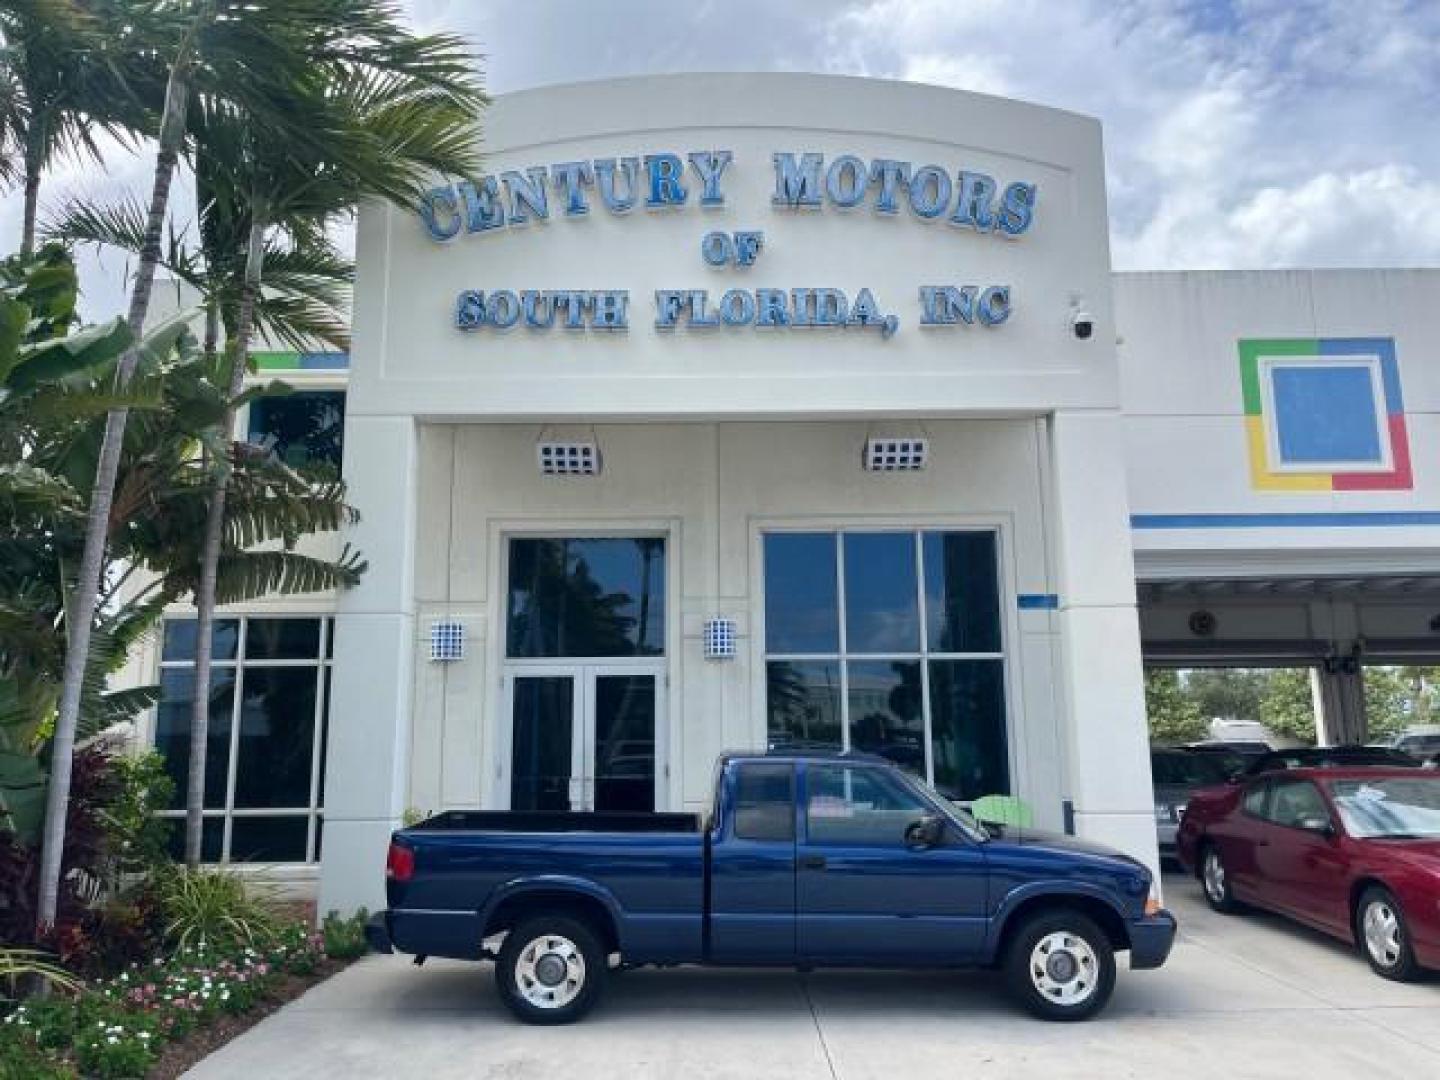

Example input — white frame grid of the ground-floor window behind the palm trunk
[150,612,336,867]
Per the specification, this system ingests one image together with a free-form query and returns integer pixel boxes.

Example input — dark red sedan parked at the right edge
[1176,768,1440,979]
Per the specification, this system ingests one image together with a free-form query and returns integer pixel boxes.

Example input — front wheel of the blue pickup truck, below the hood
[1005,910,1115,1021]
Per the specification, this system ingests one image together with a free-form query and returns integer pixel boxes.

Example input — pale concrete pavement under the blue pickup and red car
[190,876,1440,1080]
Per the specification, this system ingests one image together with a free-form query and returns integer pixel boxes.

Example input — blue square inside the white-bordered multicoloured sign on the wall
[1270,364,1385,465]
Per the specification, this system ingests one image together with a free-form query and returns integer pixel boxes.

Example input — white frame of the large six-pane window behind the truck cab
[750,517,1025,793]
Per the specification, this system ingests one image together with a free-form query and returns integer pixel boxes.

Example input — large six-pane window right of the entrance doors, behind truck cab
[765,530,1009,799]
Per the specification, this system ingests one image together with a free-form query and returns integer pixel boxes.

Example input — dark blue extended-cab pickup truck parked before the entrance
[369,752,1175,1024]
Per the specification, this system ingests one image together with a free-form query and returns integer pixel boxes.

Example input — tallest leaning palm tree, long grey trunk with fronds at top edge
[37,0,480,927]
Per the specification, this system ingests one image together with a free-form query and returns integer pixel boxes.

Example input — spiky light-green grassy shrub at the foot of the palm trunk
[153,867,276,949]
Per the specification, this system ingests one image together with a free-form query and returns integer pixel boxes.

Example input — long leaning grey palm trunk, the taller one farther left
[36,38,200,933]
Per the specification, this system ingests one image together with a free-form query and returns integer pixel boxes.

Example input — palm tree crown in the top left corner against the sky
[0,0,154,255]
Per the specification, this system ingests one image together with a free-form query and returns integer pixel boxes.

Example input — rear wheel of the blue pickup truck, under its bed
[495,914,609,1024]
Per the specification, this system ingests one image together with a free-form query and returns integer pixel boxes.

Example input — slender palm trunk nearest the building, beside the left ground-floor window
[184,196,266,867]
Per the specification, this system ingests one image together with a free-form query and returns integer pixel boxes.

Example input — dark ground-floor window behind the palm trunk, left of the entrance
[156,616,333,863]
